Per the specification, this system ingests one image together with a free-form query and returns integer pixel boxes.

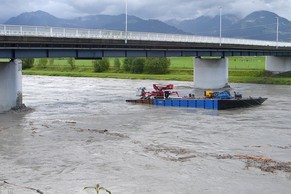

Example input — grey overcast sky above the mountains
[0,0,291,21]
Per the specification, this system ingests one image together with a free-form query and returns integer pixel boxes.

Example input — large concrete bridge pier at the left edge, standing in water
[0,60,22,113]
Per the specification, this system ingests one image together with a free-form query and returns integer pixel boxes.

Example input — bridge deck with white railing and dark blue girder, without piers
[0,25,291,58]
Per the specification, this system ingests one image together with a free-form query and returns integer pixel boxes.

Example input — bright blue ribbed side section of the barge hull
[154,99,218,110]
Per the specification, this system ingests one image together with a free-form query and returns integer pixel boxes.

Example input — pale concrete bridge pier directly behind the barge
[194,57,228,89]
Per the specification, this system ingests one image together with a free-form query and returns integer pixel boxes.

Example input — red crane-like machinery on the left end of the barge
[137,84,179,99]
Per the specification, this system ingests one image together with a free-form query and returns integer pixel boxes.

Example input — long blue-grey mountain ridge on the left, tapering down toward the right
[5,11,185,34]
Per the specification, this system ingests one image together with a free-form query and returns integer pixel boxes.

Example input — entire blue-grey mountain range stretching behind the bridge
[5,11,291,42]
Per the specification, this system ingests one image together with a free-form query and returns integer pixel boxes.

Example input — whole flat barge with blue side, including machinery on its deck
[126,84,267,110]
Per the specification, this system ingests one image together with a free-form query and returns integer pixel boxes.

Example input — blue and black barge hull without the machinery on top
[126,97,267,110]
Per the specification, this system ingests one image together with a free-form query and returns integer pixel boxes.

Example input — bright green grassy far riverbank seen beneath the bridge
[23,57,291,85]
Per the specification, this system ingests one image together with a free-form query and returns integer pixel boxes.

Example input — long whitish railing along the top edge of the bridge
[0,25,291,47]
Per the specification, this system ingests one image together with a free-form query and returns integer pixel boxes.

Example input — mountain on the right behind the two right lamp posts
[167,11,291,41]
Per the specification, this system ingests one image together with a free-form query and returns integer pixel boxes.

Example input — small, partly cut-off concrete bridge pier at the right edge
[265,56,291,73]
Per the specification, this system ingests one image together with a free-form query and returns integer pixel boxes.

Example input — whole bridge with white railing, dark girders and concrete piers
[0,25,291,112]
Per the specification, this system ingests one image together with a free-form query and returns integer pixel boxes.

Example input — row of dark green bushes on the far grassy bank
[22,58,171,74]
